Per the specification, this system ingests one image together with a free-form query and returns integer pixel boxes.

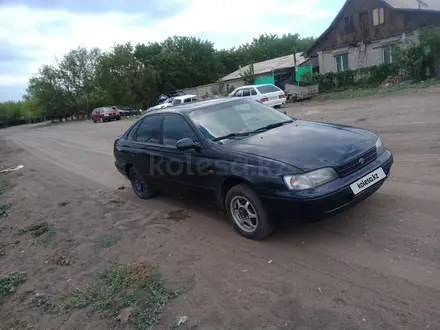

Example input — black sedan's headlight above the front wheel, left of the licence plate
[284,167,338,190]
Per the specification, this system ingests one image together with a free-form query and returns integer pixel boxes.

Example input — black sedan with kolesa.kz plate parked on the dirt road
[114,99,393,239]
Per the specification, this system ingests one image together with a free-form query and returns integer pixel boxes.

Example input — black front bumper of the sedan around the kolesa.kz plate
[259,150,393,216]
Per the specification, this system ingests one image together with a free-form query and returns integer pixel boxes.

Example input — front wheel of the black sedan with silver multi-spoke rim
[225,184,275,240]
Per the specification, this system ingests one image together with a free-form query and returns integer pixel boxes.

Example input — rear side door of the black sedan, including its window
[131,114,167,189]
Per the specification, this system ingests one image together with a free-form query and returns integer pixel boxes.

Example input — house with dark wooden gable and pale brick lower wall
[305,0,440,73]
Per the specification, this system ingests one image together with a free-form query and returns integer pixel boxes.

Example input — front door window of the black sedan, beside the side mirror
[163,115,197,147]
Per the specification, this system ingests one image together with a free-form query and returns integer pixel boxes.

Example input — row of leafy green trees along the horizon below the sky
[0,34,314,126]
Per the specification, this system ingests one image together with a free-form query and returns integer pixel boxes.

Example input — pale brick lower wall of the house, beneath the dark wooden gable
[318,32,419,73]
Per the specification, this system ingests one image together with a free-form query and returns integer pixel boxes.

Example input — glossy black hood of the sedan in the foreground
[222,120,377,172]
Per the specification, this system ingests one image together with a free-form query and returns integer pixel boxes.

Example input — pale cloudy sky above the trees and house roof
[0,0,344,102]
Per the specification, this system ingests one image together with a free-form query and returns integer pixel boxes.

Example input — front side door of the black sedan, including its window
[162,114,215,194]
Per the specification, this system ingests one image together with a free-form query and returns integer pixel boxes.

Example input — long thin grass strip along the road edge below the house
[315,80,440,101]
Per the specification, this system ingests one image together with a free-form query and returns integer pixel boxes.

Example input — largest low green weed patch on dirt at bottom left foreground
[65,264,177,330]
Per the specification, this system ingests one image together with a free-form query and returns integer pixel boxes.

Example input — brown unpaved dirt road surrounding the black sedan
[0,89,440,330]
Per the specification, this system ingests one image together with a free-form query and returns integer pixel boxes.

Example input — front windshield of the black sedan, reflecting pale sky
[189,100,293,141]
